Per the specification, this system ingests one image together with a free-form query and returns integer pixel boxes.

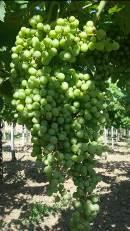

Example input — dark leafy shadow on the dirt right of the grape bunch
[92,162,130,231]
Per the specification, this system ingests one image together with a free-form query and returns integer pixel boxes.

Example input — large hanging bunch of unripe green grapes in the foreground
[11,15,119,231]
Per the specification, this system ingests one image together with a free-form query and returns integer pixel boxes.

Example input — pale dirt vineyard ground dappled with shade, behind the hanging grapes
[0,142,130,231]
